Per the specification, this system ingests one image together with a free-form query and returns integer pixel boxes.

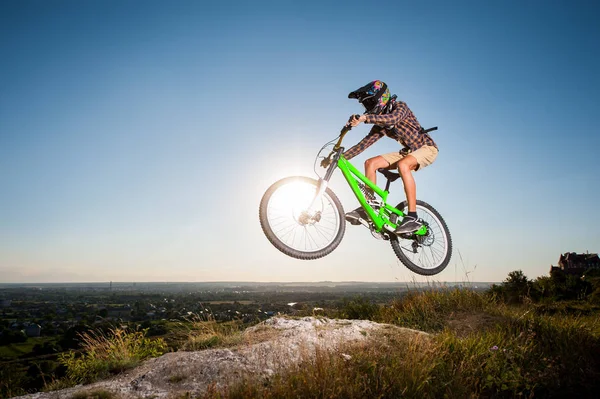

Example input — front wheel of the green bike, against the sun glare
[258,177,346,259]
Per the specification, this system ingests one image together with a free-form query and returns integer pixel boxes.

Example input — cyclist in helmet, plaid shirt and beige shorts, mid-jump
[344,80,438,234]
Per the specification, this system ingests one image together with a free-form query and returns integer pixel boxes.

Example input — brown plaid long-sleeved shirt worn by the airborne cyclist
[344,101,437,159]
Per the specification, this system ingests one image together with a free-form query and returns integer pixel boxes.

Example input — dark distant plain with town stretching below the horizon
[0,282,490,344]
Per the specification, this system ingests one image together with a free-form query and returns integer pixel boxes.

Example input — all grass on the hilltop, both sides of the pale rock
[7,273,600,399]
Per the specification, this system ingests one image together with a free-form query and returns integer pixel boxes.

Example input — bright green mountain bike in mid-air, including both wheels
[259,119,452,276]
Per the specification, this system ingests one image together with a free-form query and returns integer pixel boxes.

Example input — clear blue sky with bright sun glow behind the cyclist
[0,0,600,282]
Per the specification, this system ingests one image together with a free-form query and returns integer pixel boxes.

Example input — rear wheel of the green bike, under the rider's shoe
[390,200,452,276]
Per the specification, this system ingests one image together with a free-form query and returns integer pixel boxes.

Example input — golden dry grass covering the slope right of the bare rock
[198,290,600,398]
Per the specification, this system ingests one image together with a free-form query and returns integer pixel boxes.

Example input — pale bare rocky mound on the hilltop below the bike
[12,317,427,399]
